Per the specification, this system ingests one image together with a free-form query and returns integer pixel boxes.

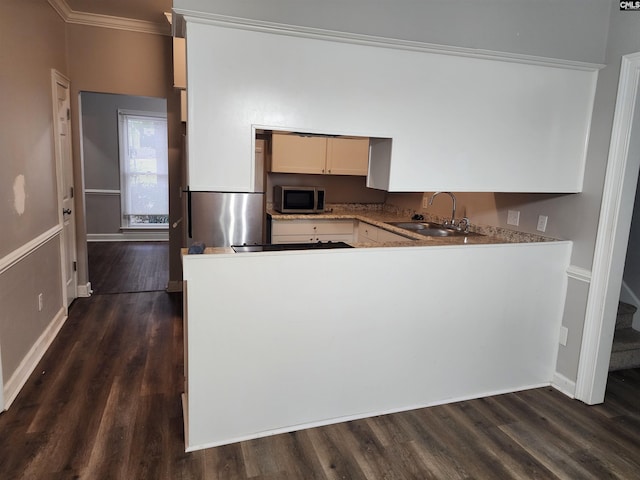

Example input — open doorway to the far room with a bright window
[80,92,169,293]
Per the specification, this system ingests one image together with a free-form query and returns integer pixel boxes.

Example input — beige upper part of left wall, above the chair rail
[0,0,67,257]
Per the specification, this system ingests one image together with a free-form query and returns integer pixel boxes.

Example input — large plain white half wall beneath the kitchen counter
[183,209,571,450]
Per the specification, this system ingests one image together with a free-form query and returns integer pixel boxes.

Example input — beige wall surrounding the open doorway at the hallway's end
[67,24,184,284]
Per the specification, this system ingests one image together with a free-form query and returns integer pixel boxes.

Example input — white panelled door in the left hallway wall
[52,70,78,307]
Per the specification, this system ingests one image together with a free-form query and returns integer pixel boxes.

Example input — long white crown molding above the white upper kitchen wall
[173,8,604,72]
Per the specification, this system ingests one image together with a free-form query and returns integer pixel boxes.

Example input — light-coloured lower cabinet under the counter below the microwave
[271,219,354,243]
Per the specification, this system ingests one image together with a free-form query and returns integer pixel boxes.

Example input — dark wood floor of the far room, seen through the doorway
[87,242,169,294]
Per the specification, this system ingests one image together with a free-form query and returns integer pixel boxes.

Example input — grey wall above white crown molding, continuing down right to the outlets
[174,0,640,390]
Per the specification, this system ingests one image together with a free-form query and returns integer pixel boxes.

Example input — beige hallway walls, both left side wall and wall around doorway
[0,0,184,400]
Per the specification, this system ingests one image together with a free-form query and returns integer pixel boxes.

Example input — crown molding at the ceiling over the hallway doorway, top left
[47,0,171,35]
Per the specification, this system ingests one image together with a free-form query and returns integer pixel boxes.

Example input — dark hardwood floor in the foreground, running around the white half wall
[0,244,640,480]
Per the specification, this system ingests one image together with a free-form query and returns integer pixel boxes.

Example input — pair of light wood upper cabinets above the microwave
[271,133,369,176]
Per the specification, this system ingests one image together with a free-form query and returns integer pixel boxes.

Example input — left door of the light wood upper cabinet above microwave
[271,133,327,173]
